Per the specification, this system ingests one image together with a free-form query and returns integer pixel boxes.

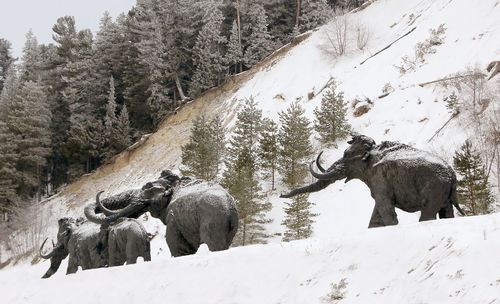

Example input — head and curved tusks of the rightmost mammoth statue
[309,133,375,182]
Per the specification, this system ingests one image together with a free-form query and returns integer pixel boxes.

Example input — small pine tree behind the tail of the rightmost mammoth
[453,140,494,215]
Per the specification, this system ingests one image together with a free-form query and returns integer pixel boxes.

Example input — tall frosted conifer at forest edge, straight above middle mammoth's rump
[189,1,227,96]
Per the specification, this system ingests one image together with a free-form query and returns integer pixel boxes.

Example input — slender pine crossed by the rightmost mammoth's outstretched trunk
[278,102,316,241]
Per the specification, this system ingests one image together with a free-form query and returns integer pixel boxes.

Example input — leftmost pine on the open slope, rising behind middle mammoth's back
[181,114,225,180]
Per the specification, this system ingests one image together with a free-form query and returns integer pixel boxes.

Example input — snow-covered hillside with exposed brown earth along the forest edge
[0,0,500,303]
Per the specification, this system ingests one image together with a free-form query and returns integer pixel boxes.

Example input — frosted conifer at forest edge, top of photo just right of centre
[243,2,274,67]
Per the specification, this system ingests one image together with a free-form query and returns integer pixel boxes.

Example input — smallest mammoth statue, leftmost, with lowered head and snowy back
[40,217,151,278]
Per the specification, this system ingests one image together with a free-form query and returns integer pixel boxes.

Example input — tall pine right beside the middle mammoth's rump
[222,98,272,246]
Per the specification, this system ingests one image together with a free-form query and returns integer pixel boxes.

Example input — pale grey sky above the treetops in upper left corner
[0,0,136,58]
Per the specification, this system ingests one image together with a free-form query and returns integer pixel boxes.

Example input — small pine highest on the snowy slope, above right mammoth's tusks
[314,82,351,145]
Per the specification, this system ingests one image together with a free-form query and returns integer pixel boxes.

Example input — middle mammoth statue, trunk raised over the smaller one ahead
[85,170,238,257]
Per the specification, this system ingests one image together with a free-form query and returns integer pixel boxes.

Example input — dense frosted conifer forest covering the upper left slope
[0,0,364,218]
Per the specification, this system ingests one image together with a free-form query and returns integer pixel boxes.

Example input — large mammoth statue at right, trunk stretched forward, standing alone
[280,134,464,228]
